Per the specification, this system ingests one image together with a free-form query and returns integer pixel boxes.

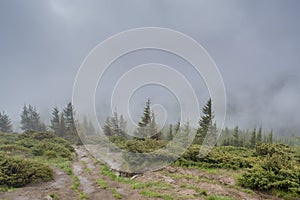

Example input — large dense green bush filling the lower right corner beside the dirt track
[239,144,300,196]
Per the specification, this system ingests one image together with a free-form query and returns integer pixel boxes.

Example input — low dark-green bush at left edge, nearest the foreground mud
[0,154,54,187]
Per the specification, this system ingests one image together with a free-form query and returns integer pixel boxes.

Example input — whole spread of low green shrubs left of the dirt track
[0,131,75,188]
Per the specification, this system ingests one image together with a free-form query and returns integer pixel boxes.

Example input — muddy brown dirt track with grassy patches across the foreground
[0,147,286,200]
